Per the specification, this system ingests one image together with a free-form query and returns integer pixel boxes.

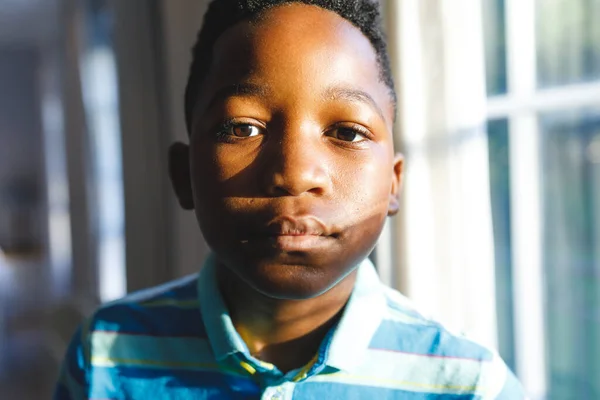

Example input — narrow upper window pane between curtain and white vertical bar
[483,0,507,96]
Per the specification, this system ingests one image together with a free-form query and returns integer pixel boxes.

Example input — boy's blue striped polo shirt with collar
[54,256,525,400]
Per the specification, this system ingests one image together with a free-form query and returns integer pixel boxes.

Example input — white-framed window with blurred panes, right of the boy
[484,0,600,400]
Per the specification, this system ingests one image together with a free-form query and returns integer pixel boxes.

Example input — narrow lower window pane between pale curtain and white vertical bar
[488,119,515,370]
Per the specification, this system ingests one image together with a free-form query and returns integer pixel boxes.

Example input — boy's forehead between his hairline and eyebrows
[200,4,394,124]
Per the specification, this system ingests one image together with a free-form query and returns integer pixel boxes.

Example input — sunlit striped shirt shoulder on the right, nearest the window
[360,287,522,398]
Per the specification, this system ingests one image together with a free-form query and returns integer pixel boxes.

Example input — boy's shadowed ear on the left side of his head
[169,142,194,210]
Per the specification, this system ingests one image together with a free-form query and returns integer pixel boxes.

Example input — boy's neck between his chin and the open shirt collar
[217,266,357,373]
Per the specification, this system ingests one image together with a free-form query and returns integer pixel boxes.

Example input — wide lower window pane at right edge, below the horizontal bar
[540,109,600,400]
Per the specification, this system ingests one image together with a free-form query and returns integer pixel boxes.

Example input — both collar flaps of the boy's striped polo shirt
[198,254,385,372]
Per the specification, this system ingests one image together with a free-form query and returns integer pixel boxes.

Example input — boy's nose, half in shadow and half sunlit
[260,128,331,197]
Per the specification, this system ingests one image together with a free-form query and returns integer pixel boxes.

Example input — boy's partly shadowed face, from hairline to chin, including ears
[171,4,402,299]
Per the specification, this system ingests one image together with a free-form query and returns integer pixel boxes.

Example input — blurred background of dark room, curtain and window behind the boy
[0,0,600,400]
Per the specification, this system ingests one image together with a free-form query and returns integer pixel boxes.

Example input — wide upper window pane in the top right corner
[537,0,600,87]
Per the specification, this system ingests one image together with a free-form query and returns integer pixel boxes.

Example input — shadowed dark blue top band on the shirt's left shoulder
[88,274,204,336]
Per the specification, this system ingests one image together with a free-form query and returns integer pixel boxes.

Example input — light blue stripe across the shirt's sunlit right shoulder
[369,320,492,361]
